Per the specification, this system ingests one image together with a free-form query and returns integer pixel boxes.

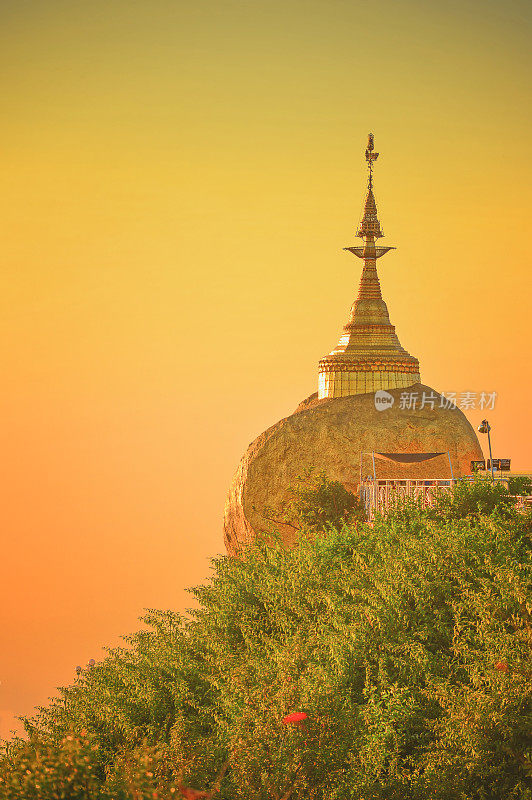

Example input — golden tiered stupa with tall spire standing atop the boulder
[318,138,421,398]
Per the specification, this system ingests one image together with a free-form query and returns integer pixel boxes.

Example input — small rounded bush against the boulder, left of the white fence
[262,468,366,531]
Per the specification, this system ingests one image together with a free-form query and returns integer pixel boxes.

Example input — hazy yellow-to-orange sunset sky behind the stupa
[0,0,532,736]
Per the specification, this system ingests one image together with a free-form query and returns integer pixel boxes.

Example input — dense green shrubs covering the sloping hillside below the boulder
[0,484,532,800]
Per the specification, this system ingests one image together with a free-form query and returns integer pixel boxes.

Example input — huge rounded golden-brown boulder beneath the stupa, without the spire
[224,383,482,555]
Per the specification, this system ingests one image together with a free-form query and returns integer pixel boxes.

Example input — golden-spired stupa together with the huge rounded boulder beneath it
[224,134,482,556]
